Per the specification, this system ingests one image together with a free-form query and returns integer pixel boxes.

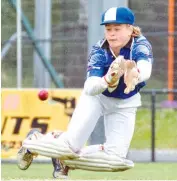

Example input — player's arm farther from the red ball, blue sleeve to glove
[124,44,153,94]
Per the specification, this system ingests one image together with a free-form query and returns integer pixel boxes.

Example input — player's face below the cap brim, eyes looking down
[105,24,133,49]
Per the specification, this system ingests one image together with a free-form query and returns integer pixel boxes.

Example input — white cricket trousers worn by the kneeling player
[63,92,140,157]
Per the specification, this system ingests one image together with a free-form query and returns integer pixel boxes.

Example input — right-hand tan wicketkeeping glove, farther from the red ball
[124,60,140,94]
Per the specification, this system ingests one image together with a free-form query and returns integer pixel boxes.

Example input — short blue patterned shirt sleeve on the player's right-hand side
[132,42,153,63]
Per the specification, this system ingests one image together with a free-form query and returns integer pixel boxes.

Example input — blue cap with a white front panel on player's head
[100,7,135,25]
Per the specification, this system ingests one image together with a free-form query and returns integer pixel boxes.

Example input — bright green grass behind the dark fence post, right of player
[131,109,177,149]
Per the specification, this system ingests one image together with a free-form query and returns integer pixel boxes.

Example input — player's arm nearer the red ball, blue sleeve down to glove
[84,50,123,96]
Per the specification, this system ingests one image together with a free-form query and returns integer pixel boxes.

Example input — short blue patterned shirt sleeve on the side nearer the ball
[87,48,106,78]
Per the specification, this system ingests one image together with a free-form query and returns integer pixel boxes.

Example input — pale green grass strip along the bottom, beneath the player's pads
[1,163,177,181]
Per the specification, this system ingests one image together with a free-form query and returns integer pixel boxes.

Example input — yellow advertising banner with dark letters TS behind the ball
[1,89,81,158]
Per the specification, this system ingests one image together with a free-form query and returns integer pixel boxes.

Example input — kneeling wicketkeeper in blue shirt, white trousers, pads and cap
[18,7,153,179]
